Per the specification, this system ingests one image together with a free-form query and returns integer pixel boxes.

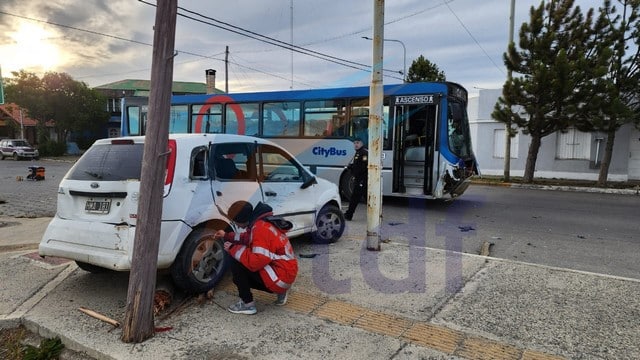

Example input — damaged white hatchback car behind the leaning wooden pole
[39,134,345,293]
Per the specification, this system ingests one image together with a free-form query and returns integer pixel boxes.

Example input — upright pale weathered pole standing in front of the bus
[367,0,384,251]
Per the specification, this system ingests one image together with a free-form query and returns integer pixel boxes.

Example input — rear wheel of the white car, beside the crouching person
[171,228,230,294]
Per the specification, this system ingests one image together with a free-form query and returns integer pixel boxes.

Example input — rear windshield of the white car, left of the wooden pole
[67,143,144,181]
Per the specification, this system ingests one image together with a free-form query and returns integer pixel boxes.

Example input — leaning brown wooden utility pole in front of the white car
[122,0,178,343]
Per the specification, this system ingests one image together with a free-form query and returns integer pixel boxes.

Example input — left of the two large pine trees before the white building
[492,0,593,183]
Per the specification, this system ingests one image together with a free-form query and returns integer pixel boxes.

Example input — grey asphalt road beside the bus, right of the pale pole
[376,184,640,279]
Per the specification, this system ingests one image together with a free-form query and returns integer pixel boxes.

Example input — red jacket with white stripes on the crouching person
[225,219,298,294]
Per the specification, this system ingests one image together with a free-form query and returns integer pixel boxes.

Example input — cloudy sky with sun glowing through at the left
[0,0,604,97]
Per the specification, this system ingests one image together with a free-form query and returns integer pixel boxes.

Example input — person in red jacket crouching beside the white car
[216,201,298,315]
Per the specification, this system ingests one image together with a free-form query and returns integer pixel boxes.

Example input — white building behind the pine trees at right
[469,89,640,181]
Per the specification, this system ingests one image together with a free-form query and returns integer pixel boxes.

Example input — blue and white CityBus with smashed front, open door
[121,82,478,199]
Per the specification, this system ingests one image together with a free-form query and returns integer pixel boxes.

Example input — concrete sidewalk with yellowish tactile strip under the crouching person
[0,218,640,360]
